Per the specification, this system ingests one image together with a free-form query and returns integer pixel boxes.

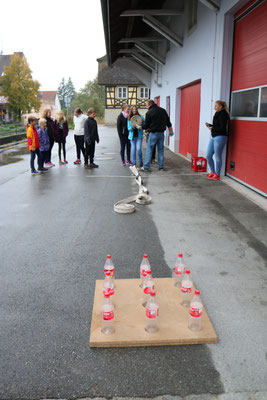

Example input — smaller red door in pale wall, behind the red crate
[179,82,201,157]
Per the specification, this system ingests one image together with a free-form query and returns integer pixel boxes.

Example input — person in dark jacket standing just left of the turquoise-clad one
[117,104,132,167]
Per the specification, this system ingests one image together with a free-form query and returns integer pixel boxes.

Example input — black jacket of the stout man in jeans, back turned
[142,104,172,132]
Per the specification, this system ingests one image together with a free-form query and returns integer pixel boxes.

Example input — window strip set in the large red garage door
[231,86,267,118]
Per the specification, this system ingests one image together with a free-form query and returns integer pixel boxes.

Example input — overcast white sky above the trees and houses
[0,0,106,90]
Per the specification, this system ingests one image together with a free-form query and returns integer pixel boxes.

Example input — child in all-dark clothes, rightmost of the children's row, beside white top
[84,108,99,168]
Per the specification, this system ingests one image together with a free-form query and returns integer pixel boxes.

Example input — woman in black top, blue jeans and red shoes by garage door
[205,100,229,180]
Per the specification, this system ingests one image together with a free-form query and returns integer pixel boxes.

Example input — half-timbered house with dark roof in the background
[97,56,150,124]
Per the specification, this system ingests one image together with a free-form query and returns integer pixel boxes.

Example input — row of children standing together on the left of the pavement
[27,108,99,175]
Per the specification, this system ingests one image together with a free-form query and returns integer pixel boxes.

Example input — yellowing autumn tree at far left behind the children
[0,54,41,121]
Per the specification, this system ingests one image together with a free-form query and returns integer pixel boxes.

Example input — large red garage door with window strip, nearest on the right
[227,0,267,195]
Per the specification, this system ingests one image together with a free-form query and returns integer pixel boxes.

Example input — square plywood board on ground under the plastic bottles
[90,278,217,347]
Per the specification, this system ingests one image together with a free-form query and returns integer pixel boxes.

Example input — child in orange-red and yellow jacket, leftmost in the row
[27,116,44,175]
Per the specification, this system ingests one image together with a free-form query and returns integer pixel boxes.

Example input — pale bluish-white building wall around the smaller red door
[151,0,244,166]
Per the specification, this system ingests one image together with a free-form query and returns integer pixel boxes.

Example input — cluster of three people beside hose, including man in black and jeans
[117,100,173,171]
